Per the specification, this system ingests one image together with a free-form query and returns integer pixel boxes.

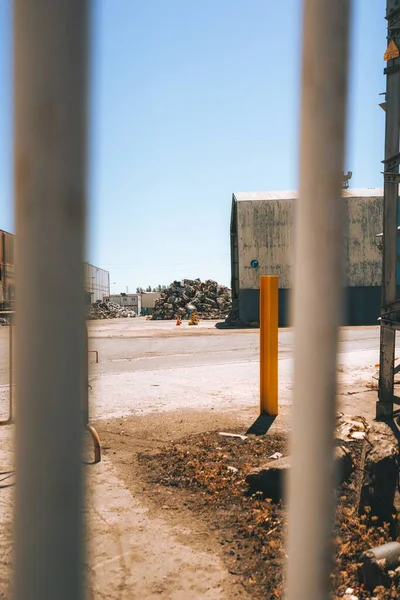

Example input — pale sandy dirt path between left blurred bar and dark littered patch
[89,411,262,600]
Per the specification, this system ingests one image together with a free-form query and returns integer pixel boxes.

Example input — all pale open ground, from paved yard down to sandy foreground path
[0,319,396,600]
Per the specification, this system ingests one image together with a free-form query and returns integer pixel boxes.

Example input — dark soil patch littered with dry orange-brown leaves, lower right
[139,432,400,600]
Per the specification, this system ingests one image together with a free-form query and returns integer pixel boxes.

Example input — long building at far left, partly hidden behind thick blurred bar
[0,230,110,306]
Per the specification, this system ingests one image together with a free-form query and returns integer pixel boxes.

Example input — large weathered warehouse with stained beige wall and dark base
[231,188,390,326]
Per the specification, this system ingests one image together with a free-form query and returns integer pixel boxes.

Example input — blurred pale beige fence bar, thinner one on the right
[287,0,351,600]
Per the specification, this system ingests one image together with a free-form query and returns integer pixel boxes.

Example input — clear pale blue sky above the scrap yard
[0,0,386,292]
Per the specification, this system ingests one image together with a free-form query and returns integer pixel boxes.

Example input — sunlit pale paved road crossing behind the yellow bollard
[0,319,394,418]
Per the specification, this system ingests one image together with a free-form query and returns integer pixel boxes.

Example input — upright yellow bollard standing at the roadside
[260,276,279,417]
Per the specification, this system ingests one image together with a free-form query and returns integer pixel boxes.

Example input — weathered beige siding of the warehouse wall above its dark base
[237,195,384,290]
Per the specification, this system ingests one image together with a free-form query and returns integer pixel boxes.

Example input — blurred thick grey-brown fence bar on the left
[14,0,88,600]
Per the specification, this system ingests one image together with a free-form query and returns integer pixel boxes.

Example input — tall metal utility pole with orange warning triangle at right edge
[376,0,400,419]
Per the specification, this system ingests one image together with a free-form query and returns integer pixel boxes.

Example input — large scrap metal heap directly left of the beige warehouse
[153,279,232,320]
